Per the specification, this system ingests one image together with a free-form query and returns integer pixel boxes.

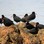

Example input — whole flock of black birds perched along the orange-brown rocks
[0,12,44,34]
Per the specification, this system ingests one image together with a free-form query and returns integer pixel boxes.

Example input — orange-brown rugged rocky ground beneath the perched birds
[0,22,44,44]
